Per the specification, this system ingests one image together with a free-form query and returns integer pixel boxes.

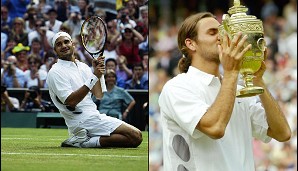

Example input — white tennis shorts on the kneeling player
[73,114,123,137]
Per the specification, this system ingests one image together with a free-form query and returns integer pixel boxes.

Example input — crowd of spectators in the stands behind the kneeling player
[1,0,149,121]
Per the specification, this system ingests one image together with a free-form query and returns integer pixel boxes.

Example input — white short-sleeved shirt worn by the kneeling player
[47,59,100,130]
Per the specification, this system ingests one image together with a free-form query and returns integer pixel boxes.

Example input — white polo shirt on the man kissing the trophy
[159,66,271,171]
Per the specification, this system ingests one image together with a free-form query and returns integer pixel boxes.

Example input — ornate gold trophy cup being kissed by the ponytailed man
[218,0,266,97]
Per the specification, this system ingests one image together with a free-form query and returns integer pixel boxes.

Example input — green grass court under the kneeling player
[1,128,148,171]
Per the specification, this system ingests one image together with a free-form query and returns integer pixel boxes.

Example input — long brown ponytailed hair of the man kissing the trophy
[178,12,215,73]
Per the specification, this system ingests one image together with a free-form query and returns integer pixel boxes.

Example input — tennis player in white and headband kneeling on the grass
[47,32,142,147]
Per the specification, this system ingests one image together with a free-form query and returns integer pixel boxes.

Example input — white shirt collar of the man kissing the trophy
[187,66,219,86]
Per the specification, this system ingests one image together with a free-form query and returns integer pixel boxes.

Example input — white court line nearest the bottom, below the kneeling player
[1,152,148,158]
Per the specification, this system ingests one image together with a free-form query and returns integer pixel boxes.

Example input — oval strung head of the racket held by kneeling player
[80,16,108,58]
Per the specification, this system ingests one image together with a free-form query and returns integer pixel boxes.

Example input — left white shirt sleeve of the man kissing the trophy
[159,85,210,138]
